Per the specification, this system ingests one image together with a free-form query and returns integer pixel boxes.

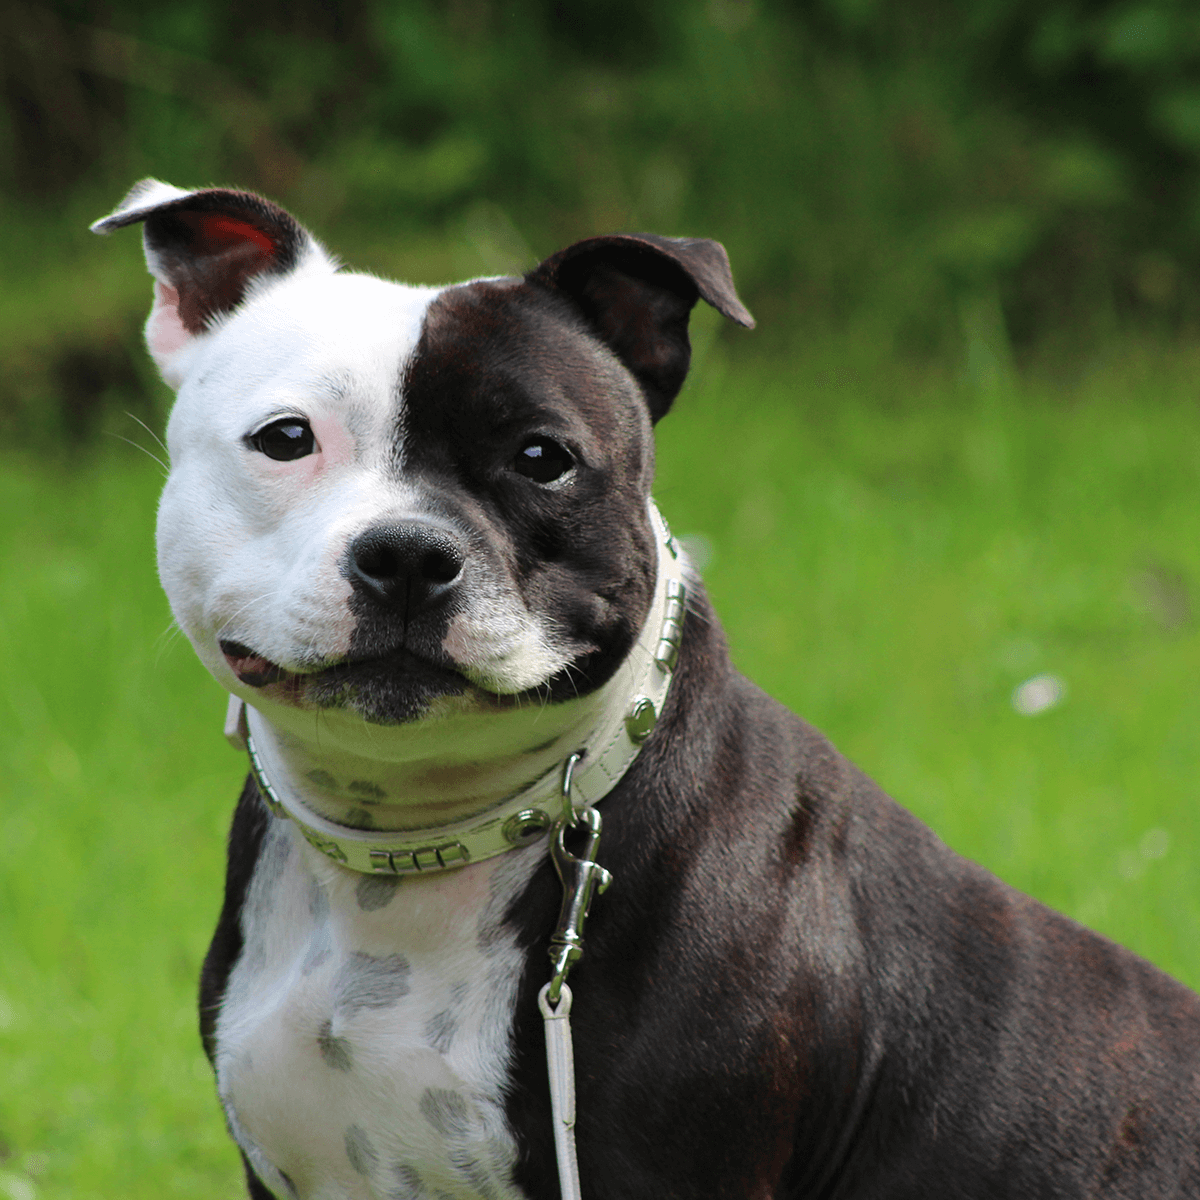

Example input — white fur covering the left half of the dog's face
[158,274,436,686]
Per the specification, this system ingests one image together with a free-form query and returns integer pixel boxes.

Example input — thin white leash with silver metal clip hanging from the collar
[538,754,612,1200]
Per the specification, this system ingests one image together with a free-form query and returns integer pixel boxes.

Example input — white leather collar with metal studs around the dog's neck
[226,502,686,875]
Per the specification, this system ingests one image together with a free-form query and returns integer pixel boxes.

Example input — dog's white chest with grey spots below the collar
[217,820,540,1200]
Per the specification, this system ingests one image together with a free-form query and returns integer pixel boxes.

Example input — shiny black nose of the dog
[349,521,467,617]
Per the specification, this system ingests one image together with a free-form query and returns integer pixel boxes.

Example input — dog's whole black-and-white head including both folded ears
[94,180,752,725]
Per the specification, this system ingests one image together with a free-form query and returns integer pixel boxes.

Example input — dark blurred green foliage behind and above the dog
[7,0,1200,433]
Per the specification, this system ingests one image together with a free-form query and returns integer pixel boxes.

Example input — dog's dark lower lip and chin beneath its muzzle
[221,642,475,725]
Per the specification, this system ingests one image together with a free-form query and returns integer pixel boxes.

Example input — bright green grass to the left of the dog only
[0,454,241,1200]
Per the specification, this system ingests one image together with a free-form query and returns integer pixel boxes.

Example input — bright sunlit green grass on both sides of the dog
[0,347,1200,1200]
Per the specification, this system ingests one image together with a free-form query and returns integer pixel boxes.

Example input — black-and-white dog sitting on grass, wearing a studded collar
[92,180,1200,1200]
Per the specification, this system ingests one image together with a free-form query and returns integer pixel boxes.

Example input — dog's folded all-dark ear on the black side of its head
[527,233,754,421]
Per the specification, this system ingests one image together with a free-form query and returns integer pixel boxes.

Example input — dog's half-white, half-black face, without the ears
[158,266,653,722]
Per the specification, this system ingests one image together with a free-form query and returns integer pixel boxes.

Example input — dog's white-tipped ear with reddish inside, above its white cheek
[91,179,337,388]
